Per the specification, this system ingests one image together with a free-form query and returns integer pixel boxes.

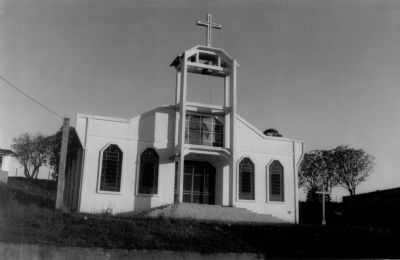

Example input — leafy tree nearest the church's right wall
[299,150,337,201]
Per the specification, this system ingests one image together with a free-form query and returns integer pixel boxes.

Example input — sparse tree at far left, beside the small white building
[12,133,48,179]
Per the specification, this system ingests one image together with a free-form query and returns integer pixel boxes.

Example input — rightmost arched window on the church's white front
[269,161,284,201]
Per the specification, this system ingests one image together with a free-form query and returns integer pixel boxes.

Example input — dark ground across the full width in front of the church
[0,178,400,257]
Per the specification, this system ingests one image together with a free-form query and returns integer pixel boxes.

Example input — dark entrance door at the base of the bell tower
[183,161,215,204]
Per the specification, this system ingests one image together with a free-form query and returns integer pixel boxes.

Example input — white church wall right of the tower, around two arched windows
[234,117,302,223]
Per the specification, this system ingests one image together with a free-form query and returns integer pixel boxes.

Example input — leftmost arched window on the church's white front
[100,144,122,191]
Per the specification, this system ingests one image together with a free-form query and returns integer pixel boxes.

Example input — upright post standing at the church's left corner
[56,117,69,210]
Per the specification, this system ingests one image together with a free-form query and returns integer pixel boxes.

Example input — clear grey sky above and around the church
[0,0,400,199]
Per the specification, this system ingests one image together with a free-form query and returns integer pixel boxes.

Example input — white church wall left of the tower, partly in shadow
[76,107,175,213]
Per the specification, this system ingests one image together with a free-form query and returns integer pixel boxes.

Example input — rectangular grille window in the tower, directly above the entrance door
[185,114,224,147]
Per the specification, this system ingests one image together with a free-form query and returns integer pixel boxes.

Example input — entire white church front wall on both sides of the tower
[76,106,302,222]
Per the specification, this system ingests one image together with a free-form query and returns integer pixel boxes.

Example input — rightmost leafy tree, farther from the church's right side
[332,145,374,196]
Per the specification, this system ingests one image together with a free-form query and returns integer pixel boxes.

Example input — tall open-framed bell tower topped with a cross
[171,14,239,206]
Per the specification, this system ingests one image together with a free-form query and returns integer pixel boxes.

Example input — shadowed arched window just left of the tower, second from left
[139,148,159,194]
